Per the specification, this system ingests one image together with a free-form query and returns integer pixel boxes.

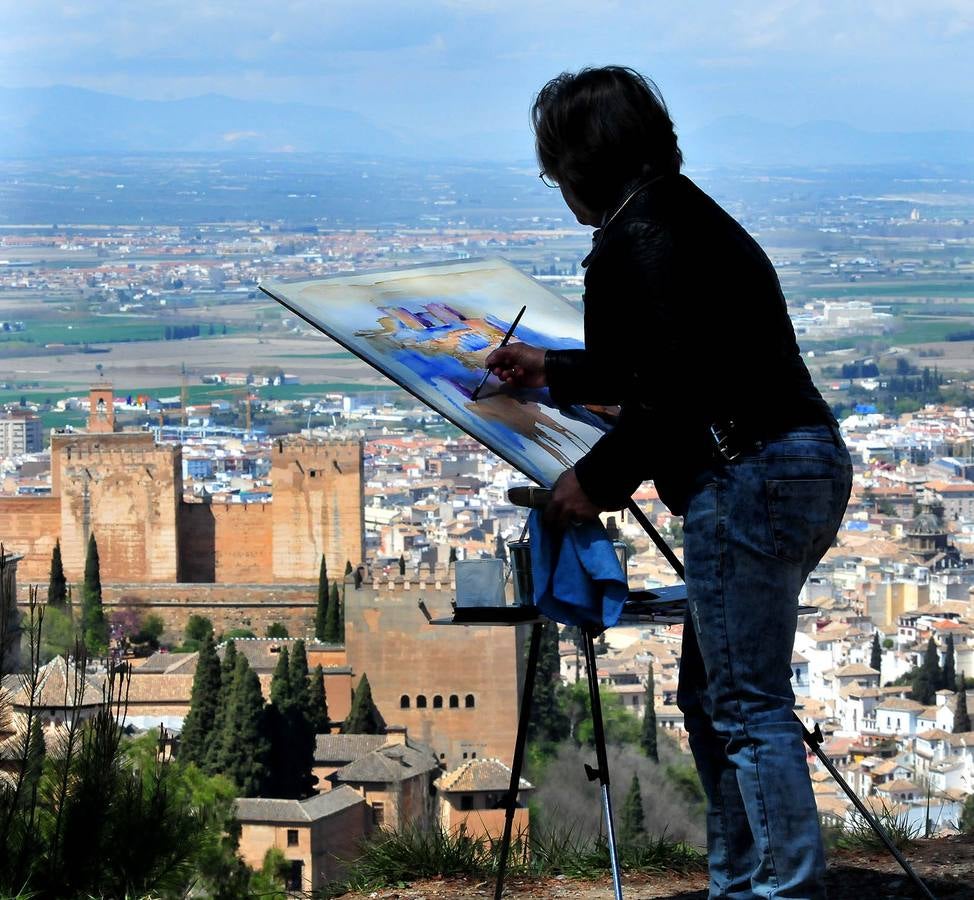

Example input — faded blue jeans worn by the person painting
[677,425,852,900]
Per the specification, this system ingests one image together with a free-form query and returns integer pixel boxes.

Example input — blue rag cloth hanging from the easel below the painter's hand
[528,509,629,630]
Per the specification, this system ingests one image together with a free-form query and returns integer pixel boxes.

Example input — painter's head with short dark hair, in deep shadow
[531,66,683,210]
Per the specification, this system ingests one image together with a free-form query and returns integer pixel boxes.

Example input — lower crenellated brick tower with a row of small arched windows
[345,578,528,768]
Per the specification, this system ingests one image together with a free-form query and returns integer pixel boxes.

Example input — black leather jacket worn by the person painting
[545,175,834,514]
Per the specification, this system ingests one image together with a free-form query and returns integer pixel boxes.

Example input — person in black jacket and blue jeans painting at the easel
[487,66,852,898]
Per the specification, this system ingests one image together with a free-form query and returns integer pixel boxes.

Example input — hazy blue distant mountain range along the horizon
[0,87,974,167]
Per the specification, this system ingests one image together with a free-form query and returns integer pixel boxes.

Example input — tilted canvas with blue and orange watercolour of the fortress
[261,259,608,486]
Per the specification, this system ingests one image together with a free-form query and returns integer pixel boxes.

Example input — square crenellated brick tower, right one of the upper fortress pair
[271,439,365,582]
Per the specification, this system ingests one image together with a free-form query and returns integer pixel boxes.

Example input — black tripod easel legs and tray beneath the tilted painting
[434,501,936,900]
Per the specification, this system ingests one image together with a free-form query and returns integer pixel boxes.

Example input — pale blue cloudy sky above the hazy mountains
[0,0,974,141]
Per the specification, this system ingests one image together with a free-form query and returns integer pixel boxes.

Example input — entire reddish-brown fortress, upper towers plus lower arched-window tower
[0,385,524,767]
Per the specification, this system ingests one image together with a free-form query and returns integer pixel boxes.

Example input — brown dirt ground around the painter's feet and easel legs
[344,836,974,900]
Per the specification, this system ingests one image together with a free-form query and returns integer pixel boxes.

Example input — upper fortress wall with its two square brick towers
[0,433,364,584]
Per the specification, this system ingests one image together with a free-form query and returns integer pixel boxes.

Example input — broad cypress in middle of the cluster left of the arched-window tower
[217,653,271,797]
